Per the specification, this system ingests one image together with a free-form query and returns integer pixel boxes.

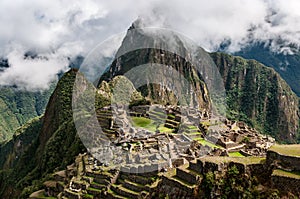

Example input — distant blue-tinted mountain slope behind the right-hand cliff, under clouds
[234,43,300,96]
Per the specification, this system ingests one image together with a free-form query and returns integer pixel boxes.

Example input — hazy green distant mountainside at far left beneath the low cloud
[0,56,83,142]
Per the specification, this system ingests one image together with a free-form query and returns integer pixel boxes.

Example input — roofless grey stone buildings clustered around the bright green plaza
[90,105,275,171]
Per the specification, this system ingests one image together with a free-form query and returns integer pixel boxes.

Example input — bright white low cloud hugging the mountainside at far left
[0,50,68,90]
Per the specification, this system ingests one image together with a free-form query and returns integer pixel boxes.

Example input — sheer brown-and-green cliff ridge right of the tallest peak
[211,53,300,142]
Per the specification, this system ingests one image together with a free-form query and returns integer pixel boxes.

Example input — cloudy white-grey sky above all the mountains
[0,0,300,89]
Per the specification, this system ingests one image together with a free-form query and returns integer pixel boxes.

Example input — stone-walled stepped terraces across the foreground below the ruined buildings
[30,145,300,199]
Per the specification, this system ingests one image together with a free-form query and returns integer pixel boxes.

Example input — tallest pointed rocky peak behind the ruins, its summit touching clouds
[100,22,211,111]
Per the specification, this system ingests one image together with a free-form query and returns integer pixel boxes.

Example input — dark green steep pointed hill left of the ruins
[0,70,85,198]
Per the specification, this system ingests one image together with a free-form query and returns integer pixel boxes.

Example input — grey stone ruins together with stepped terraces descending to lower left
[31,105,285,199]
